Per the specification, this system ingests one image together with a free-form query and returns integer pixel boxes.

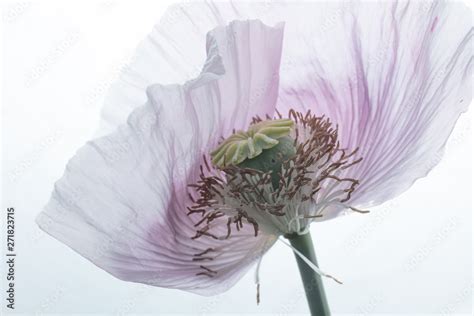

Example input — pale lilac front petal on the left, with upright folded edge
[37,21,283,295]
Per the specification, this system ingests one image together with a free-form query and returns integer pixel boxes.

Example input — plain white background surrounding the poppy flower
[0,1,473,314]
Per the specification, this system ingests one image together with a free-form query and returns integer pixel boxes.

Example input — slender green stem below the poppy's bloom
[287,232,330,316]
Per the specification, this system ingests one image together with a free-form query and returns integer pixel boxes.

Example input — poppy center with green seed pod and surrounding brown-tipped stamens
[188,110,362,239]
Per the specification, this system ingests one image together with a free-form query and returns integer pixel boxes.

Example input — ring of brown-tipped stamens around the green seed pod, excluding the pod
[188,110,362,274]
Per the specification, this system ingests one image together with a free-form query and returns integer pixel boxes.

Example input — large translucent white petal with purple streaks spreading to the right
[148,1,473,220]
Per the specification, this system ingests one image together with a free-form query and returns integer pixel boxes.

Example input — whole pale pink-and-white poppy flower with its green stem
[38,2,472,314]
